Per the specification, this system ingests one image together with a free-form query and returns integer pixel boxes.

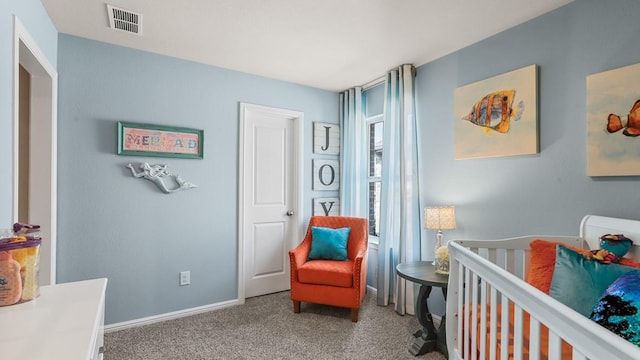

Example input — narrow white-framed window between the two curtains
[366,115,384,237]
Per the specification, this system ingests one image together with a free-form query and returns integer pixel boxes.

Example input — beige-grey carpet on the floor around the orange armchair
[104,292,445,360]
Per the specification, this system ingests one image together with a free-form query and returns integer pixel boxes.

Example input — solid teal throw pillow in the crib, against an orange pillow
[549,245,635,317]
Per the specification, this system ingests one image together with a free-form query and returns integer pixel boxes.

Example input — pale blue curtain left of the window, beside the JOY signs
[340,87,368,218]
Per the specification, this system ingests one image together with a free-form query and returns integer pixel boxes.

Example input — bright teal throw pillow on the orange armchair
[309,226,351,261]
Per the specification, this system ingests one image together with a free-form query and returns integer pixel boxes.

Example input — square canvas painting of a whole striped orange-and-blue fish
[454,65,538,159]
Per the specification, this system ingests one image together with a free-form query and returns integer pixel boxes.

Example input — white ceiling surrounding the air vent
[41,0,573,91]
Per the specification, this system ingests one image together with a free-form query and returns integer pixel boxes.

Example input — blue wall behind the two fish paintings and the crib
[416,0,640,253]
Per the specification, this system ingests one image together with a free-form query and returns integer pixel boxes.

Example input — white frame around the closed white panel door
[238,102,304,304]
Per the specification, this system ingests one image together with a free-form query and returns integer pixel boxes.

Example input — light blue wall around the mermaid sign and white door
[58,35,338,324]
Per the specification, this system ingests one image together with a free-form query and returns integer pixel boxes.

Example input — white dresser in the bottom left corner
[0,279,107,360]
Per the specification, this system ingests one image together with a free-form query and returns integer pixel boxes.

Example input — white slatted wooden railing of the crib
[446,236,640,360]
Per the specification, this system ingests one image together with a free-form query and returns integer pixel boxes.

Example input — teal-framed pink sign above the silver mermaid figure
[118,121,204,159]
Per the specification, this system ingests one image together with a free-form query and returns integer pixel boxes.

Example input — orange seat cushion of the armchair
[298,260,353,288]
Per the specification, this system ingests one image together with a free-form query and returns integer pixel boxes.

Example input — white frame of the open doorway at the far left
[13,15,58,285]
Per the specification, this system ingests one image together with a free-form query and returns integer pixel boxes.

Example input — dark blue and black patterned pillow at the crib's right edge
[590,270,640,346]
